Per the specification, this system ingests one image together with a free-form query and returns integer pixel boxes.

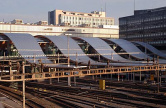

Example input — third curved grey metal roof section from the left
[81,37,141,62]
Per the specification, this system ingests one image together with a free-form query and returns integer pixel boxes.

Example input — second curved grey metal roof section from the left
[42,36,106,65]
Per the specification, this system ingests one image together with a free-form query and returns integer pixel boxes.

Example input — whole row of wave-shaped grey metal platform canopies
[0,33,166,66]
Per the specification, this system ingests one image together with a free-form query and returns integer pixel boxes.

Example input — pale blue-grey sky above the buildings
[0,0,166,24]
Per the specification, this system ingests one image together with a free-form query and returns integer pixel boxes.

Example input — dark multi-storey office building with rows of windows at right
[119,7,166,49]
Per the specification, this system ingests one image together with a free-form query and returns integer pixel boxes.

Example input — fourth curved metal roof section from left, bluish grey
[108,39,152,59]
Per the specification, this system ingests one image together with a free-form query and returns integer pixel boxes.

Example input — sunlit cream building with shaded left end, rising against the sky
[48,10,114,27]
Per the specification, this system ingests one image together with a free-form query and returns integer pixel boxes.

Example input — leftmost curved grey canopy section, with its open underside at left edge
[0,33,51,64]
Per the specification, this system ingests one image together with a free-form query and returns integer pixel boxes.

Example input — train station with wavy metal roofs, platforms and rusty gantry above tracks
[0,33,166,107]
